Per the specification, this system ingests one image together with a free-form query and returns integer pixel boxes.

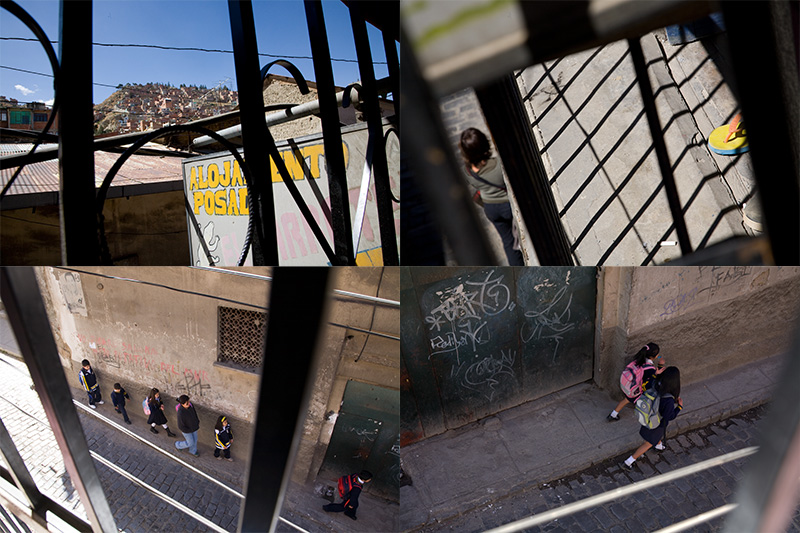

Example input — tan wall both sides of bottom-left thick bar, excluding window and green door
[37,267,400,496]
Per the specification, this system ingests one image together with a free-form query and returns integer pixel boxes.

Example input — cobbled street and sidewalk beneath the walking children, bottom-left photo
[0,336,398,533]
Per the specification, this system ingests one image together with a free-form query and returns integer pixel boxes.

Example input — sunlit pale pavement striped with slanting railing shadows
[518,30,753,265]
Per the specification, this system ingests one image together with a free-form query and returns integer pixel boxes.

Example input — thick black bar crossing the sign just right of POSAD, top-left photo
[228,0,278,266]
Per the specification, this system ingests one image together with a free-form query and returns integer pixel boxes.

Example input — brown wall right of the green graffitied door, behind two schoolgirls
[594,266,800,394]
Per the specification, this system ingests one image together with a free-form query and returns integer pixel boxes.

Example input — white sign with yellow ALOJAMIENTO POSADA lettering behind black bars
[183,122,400,266]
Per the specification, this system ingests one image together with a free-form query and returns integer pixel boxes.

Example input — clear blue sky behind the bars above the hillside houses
[0,0,388,104]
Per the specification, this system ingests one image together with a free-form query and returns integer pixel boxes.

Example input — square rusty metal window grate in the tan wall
[217,306,267,370]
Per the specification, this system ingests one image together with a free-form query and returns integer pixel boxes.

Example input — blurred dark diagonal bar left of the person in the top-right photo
[400,29,497,265]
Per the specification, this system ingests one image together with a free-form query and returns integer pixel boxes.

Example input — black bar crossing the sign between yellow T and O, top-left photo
[304,0,356,265]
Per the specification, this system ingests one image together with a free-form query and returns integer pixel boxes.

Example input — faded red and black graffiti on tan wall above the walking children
[76,333,211,396]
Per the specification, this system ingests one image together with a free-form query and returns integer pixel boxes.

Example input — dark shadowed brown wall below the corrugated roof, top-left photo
[0,190,189,265]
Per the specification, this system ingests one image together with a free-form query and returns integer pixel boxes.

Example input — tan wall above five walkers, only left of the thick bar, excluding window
[39,267,270,422]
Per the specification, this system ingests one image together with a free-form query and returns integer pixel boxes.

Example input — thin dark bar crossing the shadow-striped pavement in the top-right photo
[628,38,692,255]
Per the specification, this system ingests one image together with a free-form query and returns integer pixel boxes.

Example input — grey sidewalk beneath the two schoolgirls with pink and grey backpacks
[400,356,784,531]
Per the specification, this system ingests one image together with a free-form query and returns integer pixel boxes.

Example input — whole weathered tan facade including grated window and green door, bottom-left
[37,267,400,501]
